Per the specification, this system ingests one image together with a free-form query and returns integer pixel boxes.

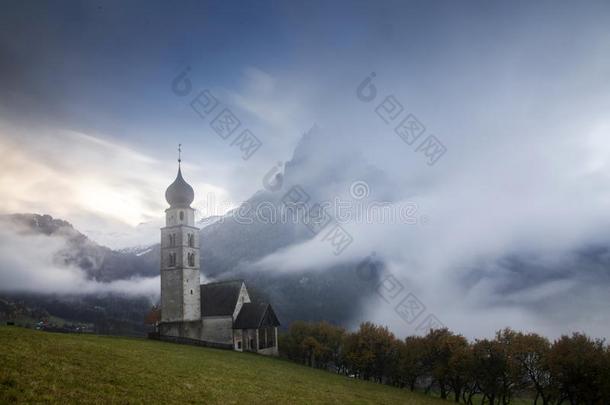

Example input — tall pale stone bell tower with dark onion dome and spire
[161,147,201,323]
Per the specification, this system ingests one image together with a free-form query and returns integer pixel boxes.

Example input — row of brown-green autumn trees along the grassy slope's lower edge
[279,321,610,405]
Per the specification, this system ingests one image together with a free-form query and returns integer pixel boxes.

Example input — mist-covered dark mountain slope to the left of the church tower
[0,214,158,335]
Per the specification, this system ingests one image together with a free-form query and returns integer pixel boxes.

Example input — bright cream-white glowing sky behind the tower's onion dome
[0,126,235,248]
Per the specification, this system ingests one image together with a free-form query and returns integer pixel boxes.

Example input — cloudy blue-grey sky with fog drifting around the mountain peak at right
[0,1,610,336]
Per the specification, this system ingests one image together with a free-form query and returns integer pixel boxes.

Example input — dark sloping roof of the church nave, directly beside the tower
[201,280,244,316]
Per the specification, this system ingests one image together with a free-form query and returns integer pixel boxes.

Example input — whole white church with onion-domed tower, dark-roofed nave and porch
[159,153,280,356]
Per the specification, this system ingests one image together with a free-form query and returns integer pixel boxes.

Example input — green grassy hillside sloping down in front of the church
[0,326,449,405]
